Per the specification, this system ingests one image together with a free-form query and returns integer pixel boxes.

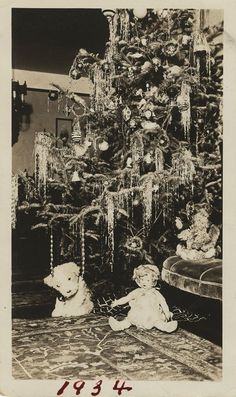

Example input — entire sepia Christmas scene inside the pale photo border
[11,7,224,384]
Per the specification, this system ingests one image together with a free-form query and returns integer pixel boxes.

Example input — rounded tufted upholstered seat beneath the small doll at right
[162,256,222,300]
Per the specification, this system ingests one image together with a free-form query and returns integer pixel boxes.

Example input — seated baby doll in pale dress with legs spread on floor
[109,265,178,333]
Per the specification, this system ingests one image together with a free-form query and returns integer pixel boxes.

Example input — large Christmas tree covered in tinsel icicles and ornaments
[13,9,223,279]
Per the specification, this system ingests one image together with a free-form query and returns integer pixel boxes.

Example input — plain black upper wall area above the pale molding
[12,8,109,74]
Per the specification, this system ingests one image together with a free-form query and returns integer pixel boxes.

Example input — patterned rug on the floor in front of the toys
[12,314,222,381]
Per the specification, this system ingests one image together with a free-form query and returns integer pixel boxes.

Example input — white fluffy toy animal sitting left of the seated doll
[44,262,93,317]
